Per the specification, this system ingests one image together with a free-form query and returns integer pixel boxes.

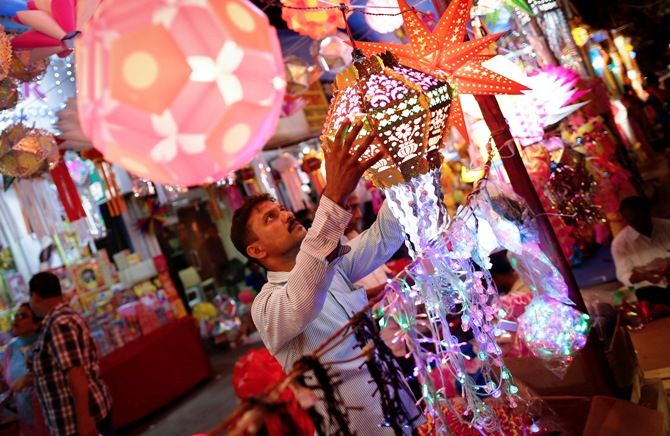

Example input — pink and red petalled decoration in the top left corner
[12,0,100,59]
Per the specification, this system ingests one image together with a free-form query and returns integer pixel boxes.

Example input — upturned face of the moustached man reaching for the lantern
[247,201,307,264]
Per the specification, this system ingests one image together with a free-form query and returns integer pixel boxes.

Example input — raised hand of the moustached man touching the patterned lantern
[323,120,382,207]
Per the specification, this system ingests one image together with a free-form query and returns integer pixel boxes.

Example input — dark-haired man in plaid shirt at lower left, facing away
[29,272,114,436]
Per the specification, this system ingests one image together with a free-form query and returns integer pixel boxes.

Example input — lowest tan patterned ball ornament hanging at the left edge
[0,124,58,177]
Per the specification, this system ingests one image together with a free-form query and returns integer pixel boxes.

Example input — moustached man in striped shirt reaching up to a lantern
[231,121,422,435]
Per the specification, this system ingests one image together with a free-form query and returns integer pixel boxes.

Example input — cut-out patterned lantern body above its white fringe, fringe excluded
[323,53,451,187]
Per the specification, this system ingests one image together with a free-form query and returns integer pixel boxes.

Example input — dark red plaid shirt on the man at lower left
[33,303,112,436]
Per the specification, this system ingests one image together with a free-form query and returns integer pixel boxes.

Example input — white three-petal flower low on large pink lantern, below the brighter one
[151,111,206,162]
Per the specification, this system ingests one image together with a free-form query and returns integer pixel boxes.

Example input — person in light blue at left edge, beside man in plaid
[0,303,48,436]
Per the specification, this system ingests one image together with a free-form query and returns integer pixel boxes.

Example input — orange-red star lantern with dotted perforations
[356,0,527,140]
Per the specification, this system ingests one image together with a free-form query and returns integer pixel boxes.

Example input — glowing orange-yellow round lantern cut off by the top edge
[281,0,349,39]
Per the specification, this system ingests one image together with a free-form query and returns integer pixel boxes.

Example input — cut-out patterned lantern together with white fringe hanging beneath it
[323,50,450,252]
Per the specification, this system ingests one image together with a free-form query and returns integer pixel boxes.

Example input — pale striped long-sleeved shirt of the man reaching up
[251,197,419,435]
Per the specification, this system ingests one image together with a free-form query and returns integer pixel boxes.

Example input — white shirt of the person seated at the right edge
[612,218,670,288]
